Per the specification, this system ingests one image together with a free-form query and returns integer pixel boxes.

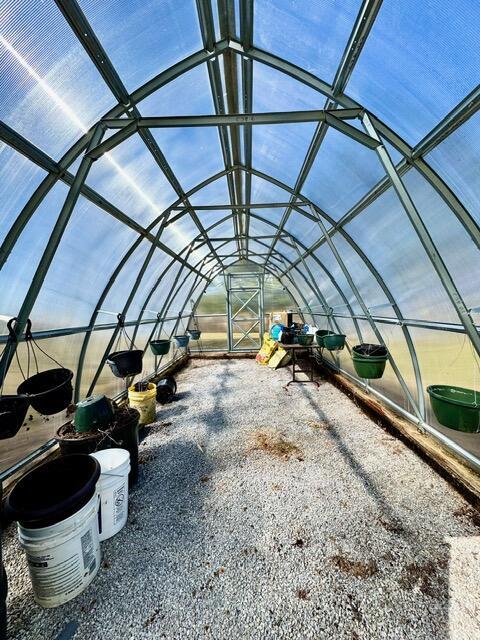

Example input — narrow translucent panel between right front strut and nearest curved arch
[404,169,480,309]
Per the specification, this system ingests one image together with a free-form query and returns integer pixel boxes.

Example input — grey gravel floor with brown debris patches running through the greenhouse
[4,360,480,640]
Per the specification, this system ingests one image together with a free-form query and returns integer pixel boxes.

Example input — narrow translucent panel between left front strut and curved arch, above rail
[0,183,67,328]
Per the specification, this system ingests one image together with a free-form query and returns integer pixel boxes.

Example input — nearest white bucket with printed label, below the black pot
[18,491,100,608]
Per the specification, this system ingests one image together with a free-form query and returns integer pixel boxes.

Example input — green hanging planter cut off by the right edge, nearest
[427,384,480,433]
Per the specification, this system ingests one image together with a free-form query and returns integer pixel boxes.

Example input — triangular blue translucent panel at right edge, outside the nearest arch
[426,114,480,223]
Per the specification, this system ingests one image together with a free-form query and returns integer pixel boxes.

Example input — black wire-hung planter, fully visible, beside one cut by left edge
[17,367,73,416]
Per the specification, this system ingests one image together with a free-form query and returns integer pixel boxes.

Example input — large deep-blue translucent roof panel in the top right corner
[347,0,480,144]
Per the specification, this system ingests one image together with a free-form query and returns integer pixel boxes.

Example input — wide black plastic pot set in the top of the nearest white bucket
[5,455,100,529]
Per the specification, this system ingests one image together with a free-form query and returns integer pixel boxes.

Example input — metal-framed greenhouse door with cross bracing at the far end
[227,273,264,351]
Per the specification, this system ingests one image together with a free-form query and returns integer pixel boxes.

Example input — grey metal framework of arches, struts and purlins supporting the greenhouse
[0,0,480,470]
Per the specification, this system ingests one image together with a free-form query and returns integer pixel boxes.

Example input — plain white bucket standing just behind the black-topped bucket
[90,449,130,542]
